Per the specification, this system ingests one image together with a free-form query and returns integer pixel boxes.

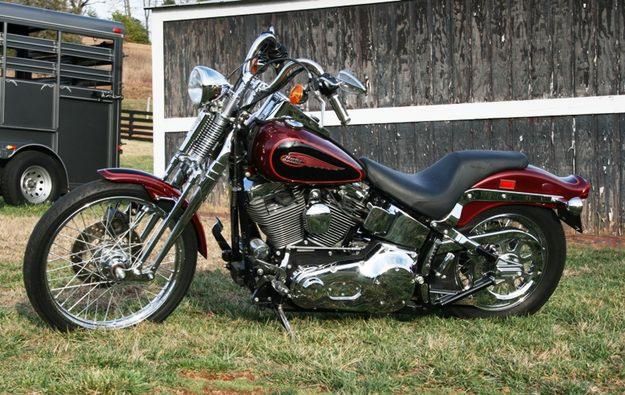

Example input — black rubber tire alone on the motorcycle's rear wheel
[448,206,566,318]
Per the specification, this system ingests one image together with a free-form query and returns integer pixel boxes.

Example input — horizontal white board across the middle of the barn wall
[159,95,625,132]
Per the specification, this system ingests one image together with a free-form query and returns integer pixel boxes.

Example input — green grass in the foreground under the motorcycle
[0,249,625,393]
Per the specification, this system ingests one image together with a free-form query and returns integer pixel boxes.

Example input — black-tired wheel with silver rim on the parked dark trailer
[2,151,63,205]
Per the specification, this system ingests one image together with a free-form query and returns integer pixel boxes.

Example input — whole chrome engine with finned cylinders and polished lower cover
[248,183,427,313]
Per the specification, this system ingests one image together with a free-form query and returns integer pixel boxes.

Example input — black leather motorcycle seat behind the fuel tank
[360,151,528,220]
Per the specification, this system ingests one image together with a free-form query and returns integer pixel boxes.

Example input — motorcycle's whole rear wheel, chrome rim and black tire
[449,206,566,318]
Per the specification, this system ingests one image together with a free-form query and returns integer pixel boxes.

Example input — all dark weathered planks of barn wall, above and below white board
[164,0,625,235]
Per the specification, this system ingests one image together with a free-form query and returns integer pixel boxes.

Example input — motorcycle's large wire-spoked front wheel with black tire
[24,180,197,330]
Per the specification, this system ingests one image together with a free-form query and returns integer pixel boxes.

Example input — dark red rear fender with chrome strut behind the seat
[457,166,590,232]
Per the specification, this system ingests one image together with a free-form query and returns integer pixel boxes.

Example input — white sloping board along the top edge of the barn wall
[152,0,401,22]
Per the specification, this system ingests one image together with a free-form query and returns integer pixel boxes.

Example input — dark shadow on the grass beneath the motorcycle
[187,270,437,328]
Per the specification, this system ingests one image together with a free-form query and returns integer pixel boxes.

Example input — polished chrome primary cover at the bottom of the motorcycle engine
[291,244,416,313]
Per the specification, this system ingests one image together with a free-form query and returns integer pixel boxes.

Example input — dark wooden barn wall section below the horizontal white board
[166,114,625,235]
